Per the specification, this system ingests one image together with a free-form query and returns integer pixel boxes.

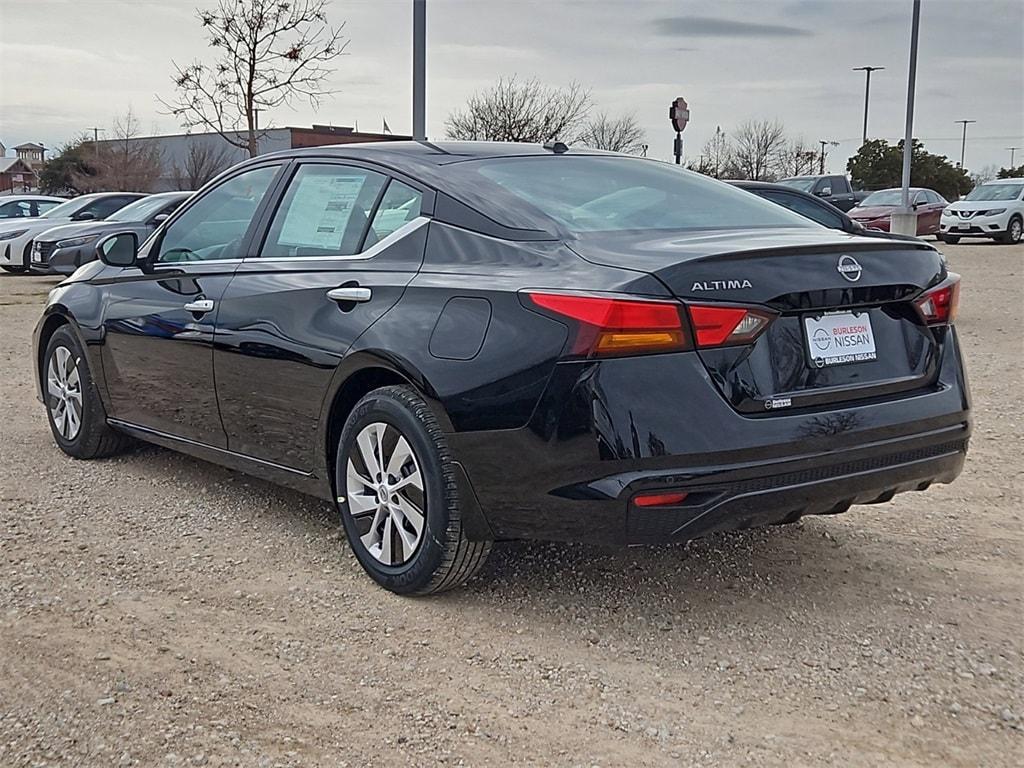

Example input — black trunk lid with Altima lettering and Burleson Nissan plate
[570,229,946,414]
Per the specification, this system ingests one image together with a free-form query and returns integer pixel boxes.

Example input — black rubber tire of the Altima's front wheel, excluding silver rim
[39,326,131,459]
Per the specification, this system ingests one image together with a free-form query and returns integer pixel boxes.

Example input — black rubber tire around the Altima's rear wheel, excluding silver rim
[335,386,492,595]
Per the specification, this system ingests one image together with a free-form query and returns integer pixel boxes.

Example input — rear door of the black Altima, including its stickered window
[214,161,433,472]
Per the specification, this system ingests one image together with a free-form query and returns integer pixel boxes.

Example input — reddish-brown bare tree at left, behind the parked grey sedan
[72,109,161,193]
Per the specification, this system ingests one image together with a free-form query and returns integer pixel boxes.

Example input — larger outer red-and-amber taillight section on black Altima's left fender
[526,291,690,357]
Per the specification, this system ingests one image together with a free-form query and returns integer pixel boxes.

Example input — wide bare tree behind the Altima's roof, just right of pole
[444,76,591,143]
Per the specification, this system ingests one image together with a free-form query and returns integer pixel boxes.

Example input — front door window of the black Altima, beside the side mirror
[157,166,278,262]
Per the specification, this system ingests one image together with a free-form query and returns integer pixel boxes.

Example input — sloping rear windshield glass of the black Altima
[450,156,817,233]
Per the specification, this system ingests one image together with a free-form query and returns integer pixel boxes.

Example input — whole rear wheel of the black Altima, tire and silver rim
[335,386,490,595]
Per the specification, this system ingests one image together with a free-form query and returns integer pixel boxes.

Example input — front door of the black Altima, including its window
[102,164,282,447]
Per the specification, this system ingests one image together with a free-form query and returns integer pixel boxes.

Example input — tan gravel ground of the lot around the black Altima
[0,244,1024,767]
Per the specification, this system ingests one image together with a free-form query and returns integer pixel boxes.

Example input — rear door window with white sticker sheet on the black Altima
[260,165,386,258]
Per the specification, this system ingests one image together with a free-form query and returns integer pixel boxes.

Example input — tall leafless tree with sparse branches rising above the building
[161,0,348,157]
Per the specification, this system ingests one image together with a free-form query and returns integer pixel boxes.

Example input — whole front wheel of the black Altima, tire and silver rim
[42,326,130,459]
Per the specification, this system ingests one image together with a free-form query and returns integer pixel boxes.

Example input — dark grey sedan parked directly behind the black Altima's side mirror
[31,191,191,274]
